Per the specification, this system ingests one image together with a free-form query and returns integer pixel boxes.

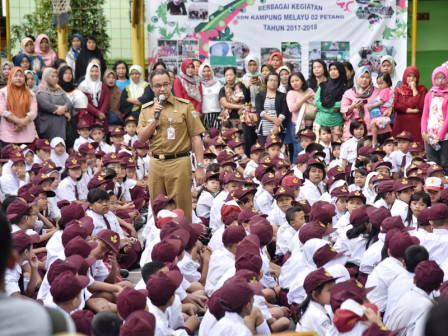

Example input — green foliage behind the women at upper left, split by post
[11,0,110,56]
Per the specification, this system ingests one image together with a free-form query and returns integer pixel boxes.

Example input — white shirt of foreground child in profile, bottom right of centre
[296,300,332,336]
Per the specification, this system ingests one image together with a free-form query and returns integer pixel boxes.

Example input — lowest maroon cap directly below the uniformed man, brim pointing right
[146,271,183,306]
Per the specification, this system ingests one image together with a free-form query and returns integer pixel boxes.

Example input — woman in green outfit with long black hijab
[313,62,347,142]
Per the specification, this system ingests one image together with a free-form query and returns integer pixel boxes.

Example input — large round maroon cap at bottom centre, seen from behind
[220,276,254,312]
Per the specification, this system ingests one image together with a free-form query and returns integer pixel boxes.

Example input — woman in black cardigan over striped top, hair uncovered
[255,72,291,145]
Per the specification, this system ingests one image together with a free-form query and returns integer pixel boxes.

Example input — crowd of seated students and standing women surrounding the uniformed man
[0,34,448,336]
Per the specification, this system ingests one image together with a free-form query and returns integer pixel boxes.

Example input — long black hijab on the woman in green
[320,62,347,108]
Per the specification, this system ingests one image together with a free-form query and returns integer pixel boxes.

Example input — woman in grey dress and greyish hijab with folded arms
[36,68,72,139]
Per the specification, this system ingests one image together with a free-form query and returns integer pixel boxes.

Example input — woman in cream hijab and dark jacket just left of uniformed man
[120,64,154,120]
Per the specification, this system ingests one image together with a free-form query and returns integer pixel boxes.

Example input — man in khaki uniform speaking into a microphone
[137,69,205,221]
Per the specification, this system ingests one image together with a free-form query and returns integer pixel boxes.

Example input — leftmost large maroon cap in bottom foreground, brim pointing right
[50,272,90,303]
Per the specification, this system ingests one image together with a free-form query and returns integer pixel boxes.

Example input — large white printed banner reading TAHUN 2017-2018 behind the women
[146,0,407,78]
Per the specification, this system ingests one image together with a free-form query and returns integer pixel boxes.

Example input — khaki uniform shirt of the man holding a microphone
[137,95,205,155]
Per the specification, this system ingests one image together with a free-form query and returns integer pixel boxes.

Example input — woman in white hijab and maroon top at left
[77,63,110,134]
